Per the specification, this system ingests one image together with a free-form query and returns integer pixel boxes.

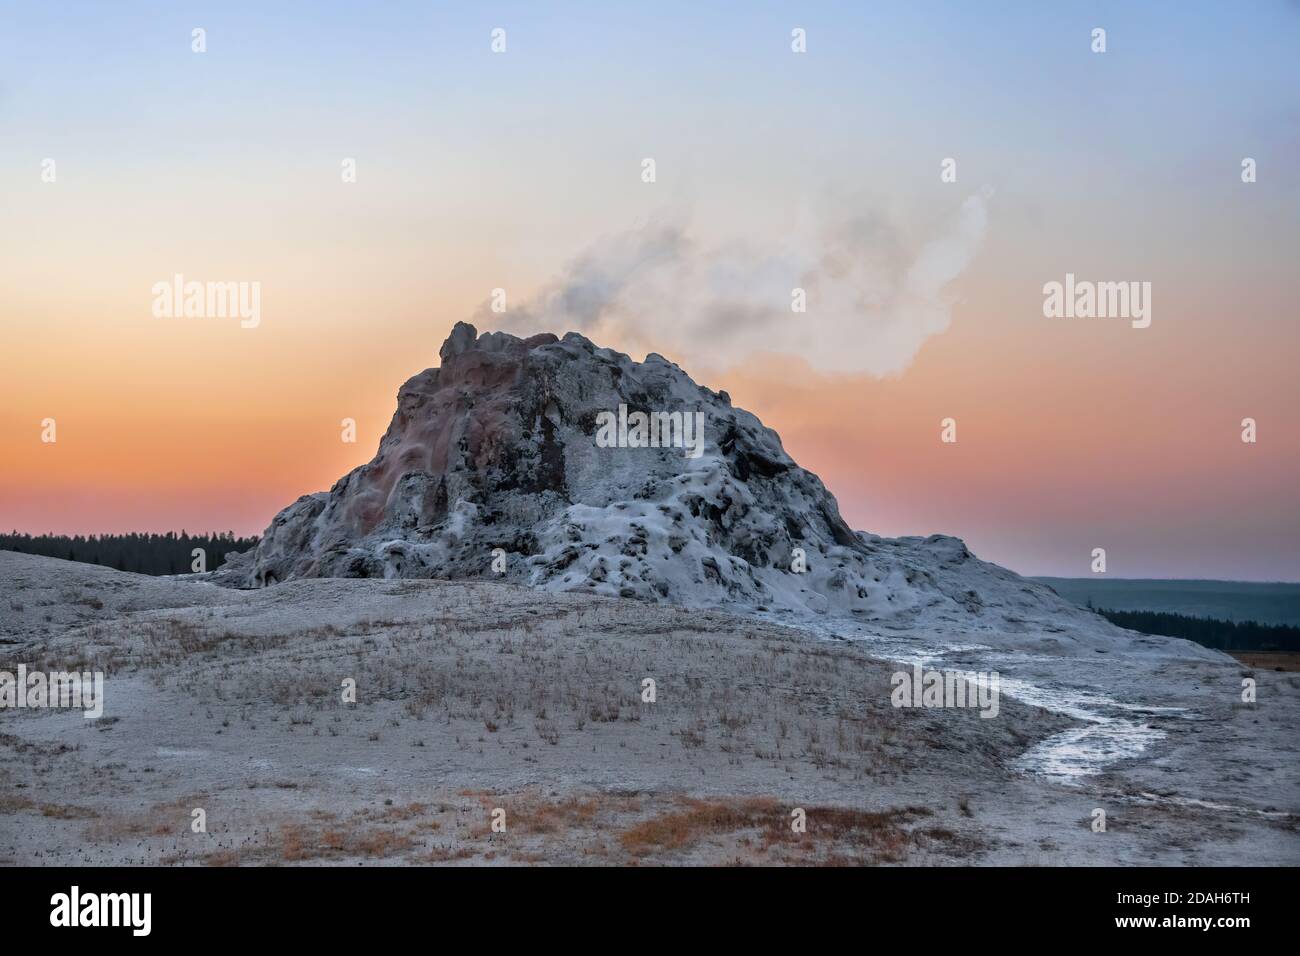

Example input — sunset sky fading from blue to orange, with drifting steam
[0,0,1300,581]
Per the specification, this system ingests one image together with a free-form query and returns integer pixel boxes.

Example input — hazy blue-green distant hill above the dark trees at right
[1034,575,1300,627]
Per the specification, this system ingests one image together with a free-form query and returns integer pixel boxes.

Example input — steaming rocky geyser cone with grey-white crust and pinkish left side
[216,323,1112,632]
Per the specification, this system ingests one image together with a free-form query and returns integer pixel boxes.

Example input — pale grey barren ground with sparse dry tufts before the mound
[0,551,1300,865]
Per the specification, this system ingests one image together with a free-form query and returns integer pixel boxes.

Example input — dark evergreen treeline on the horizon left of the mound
[0,529,257,575]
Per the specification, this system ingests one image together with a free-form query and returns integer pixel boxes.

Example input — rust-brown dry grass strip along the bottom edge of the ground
[40,790,979,866]
